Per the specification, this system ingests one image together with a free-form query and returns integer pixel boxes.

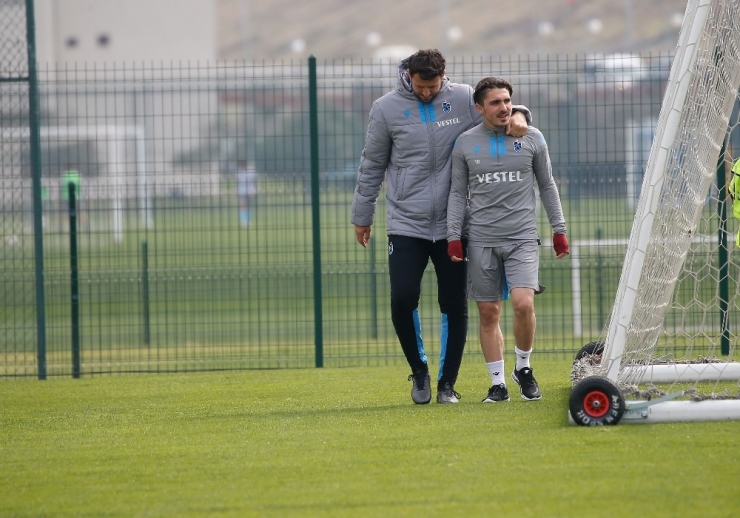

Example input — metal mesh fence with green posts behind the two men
[0,34,736,377]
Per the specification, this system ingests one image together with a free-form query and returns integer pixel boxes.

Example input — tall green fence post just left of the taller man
[308,54,324,367]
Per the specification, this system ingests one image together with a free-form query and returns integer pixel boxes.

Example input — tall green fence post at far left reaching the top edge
[26,0,46,380]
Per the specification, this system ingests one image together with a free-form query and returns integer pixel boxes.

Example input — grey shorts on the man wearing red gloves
[468,240,540,302]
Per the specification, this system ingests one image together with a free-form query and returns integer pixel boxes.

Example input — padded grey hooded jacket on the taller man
[352,59,529,241]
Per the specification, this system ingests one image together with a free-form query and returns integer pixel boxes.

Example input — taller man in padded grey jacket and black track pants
[352,49,527,404]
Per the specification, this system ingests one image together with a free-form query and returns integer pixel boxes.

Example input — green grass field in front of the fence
[0,362,740,517]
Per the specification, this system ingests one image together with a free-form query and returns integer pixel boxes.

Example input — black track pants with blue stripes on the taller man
[388,236,468,386]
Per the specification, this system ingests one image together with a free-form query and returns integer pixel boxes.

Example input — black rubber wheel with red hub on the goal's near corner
[568,376,625,426]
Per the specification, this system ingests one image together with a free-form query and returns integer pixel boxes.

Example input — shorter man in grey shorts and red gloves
[447,77,568,403]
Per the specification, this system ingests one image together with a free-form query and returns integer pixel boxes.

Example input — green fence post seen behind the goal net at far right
[717,148,730,355]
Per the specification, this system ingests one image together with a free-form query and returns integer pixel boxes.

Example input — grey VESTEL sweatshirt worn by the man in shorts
[447,123,566,246]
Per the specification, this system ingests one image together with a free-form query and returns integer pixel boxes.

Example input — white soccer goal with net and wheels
[569,0,740,425]
